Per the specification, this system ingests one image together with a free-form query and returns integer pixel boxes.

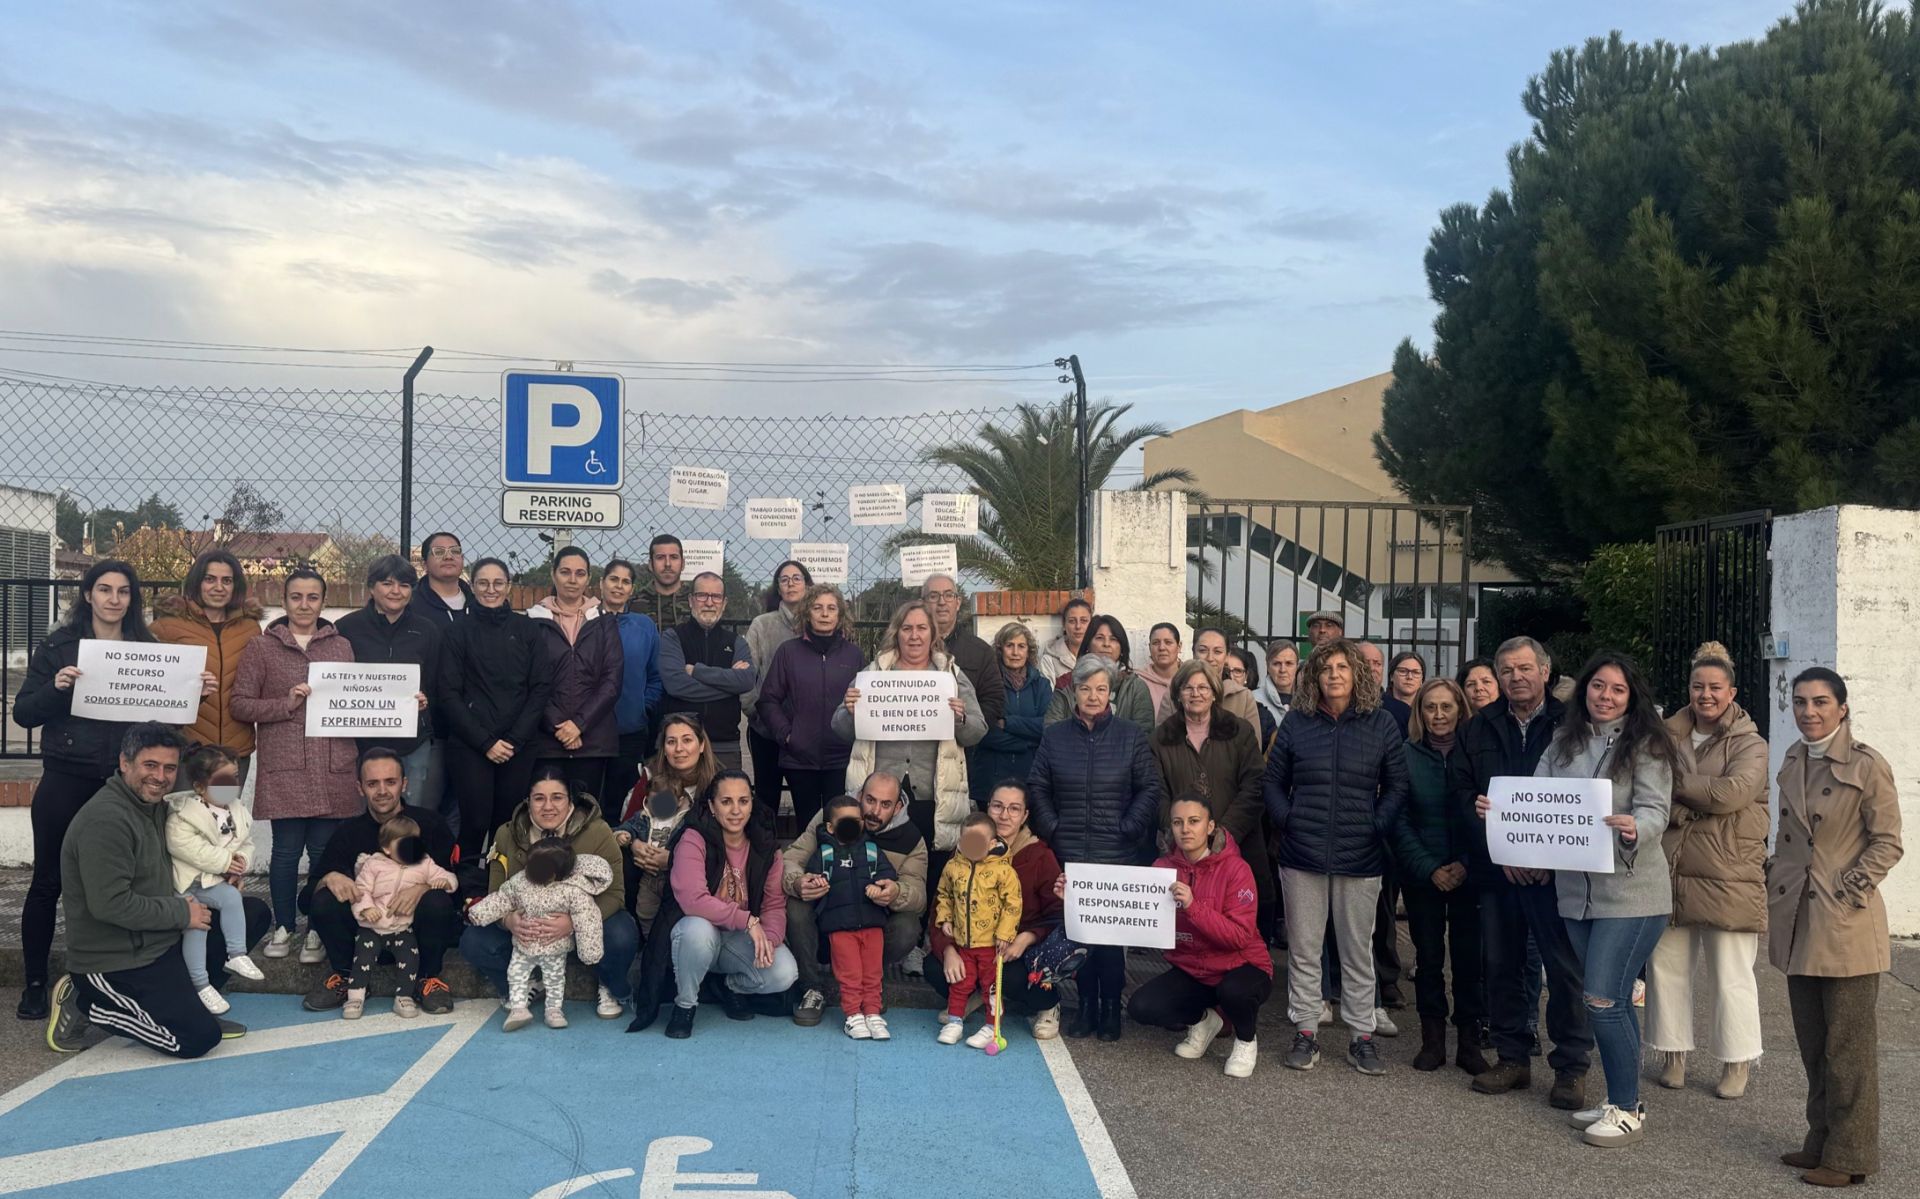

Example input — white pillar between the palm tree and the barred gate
[1092,492,1192,649]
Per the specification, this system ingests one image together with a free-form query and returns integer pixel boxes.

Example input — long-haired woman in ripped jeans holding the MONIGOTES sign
[1534,651,1676,1149]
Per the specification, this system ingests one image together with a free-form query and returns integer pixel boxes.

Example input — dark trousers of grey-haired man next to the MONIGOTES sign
[1480,882,1594,1074]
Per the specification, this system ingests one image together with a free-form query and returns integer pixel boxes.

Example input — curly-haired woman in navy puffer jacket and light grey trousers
[1265,638,1407,1074]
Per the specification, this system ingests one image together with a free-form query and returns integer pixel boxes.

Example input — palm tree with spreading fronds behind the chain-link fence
[889,394,1194,592]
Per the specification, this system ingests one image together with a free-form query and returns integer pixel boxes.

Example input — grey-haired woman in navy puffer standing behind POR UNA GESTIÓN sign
[1027,653,1160,1041]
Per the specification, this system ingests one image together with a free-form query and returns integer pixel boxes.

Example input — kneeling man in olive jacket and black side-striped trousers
[46,722,269,1057]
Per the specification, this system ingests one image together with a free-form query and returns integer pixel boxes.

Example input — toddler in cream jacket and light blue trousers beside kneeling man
[167,746,265,1016]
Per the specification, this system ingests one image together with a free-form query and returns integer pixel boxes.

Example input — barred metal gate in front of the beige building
[1187,500,1478,676]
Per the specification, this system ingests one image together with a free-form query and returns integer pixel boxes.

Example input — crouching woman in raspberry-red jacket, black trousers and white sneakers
[1133,792,1273,1078]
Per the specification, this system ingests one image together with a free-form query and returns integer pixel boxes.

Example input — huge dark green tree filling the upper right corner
[1375,0,1920,569]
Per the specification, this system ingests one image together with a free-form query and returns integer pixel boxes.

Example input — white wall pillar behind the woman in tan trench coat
[1766,505,1920,936]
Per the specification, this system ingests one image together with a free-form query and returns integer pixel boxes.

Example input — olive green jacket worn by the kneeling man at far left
[60,774,188,974]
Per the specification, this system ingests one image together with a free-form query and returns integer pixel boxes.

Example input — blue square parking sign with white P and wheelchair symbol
[499,371,624,492]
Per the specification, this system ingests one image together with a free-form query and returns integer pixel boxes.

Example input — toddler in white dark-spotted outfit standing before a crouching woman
[467,838,612,1032]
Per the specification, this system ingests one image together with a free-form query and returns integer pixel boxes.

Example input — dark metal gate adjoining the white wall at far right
[1653,509,1774,736]
